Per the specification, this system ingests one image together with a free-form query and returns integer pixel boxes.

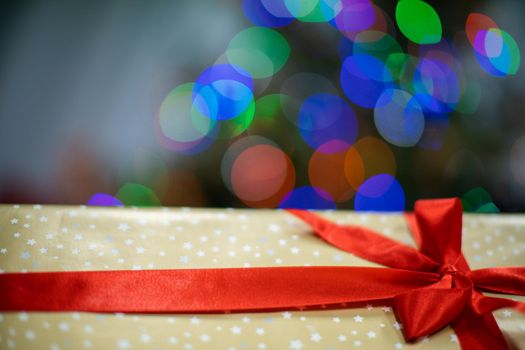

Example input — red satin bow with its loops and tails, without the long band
[291,199,525,349]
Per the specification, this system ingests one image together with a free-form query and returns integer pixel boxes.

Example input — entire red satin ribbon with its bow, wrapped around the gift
[0,199,525,350]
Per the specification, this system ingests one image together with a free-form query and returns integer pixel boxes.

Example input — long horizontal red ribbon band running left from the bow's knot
[0,266,439,313]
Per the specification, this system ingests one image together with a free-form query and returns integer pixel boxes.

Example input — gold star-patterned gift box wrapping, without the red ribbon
[0,201,525,350]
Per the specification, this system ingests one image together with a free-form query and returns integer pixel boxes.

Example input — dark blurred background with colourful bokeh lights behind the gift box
[0,0,525,212]
